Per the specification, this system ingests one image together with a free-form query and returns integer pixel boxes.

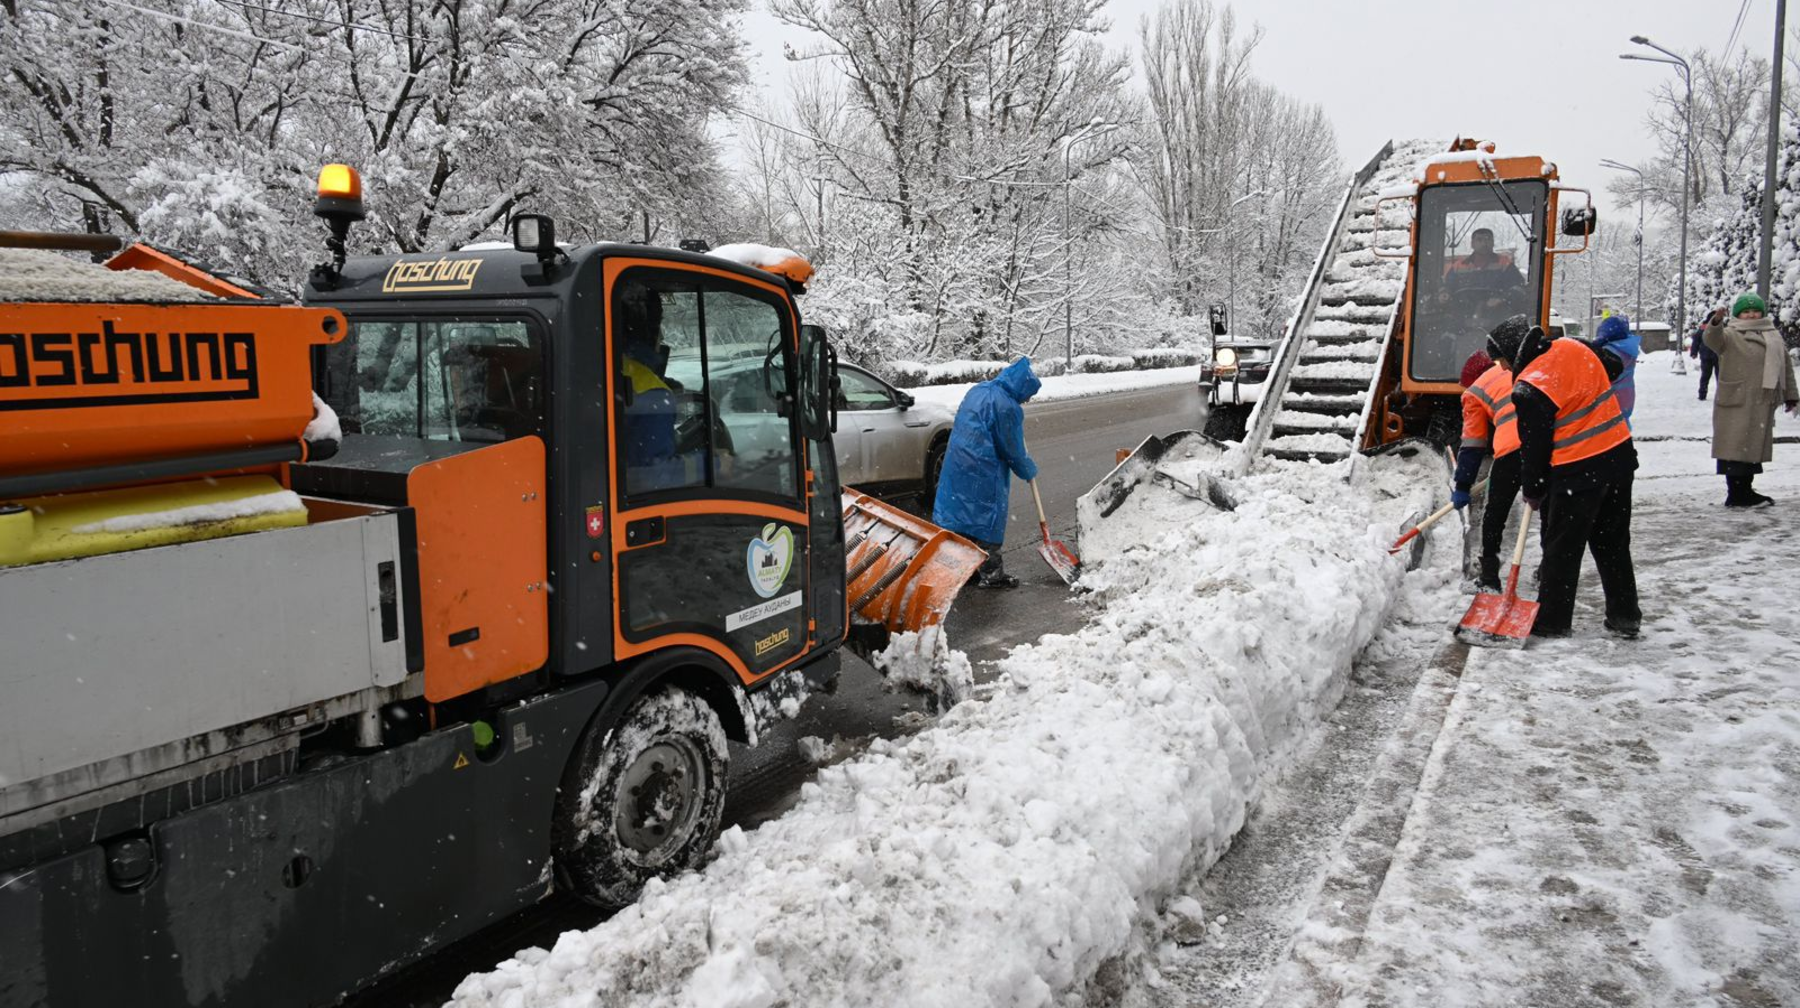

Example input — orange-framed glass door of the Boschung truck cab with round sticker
[603,257,812,682]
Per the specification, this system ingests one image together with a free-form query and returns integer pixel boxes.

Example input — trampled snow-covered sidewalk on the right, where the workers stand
[1296,355,1800,1008]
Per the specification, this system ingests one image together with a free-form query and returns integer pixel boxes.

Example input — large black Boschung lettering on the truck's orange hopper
[0,320,257,410]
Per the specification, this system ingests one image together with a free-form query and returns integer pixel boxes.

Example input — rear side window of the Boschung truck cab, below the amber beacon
[322,317,544,443]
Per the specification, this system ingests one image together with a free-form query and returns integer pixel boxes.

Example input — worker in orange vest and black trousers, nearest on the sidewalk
[1487,315,1642,637]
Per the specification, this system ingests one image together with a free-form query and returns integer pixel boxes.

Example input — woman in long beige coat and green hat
[1701,293,1800,508]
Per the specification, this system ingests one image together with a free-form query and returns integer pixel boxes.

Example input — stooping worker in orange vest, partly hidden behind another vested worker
[1451,349,1519,592]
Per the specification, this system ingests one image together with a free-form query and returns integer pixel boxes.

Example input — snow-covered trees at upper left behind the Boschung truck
[0,0,743,286]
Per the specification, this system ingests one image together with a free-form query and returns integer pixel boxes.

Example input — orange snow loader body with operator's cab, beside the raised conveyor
[1361,140,1595,450]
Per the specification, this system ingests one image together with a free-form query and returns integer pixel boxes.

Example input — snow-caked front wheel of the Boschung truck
[551,688,727,909]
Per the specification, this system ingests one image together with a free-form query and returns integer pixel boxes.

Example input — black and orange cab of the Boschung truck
[293,235,848,702]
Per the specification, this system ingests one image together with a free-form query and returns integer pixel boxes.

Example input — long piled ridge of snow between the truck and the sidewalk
[452,464,1418,1008]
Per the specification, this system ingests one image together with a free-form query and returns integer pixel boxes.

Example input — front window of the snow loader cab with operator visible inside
[1408,180,1548,382]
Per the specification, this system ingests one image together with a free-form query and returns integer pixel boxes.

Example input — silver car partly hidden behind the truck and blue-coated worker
[833,364,956,508]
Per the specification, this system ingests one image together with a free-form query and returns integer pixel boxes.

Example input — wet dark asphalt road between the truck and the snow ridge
[346,385,1204,1008]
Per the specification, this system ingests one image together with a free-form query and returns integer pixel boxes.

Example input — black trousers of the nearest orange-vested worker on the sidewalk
[1534,473,1643,632]
